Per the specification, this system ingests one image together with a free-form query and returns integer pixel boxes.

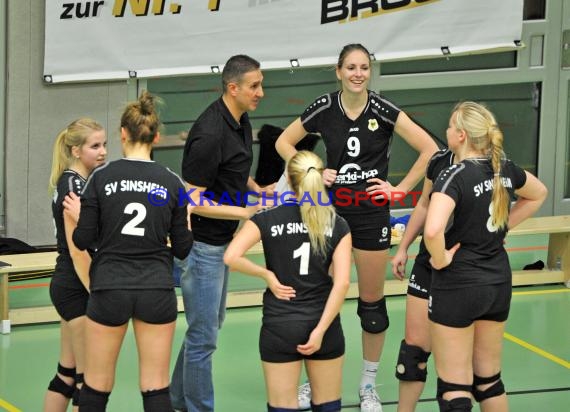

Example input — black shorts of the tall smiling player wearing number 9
[339,210,392,250]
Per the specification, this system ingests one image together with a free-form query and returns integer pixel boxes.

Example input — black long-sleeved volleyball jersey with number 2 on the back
[73,159,192,290]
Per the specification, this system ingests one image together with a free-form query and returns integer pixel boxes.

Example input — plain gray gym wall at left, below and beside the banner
[0,0,128,245]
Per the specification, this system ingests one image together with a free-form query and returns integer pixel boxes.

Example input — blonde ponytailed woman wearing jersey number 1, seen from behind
[224,151,351,412]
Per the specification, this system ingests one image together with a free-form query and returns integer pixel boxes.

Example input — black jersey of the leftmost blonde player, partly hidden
[51,169,85,286]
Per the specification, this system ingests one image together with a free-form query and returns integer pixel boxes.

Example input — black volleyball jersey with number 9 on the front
[301,91,400,214]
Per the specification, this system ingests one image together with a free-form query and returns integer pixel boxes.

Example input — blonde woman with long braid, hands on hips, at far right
[424,102,547,412]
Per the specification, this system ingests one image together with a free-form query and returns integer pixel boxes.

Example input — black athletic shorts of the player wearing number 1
[259,316,344,363]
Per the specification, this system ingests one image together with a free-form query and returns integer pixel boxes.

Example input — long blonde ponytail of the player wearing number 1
[287,150,335,256]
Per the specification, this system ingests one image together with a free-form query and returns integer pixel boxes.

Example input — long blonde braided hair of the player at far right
[453,101,510,229]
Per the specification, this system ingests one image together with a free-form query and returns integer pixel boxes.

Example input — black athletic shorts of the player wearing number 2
[87,289,178,326]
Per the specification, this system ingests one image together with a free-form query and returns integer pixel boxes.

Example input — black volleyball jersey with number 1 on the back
[251,203,349,322]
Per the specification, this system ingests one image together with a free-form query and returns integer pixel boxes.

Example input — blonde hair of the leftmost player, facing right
[48,117,103,194]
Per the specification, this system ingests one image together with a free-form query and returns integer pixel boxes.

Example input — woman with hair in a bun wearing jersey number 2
[68,92,192,412]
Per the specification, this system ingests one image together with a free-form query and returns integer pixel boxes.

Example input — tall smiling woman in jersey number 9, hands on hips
[275,44,437,412]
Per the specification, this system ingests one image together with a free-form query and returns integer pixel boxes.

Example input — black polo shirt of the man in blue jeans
[182,97,253,245]
